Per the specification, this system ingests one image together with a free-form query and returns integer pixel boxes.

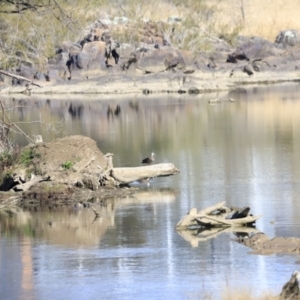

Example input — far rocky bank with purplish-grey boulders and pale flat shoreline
[0,19,300,95]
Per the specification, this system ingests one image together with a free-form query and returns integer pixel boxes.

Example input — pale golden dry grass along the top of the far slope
[87,0,300,41]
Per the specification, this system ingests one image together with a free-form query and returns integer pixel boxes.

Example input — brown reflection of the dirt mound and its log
[0,189,175,247]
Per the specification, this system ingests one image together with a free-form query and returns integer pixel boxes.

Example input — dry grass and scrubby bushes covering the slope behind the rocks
[0,0,300,69]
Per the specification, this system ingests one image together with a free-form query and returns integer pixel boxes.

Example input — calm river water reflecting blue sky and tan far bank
[0,84,300,300]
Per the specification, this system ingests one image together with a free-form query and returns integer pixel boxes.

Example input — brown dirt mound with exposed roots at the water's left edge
[0,135,148,207]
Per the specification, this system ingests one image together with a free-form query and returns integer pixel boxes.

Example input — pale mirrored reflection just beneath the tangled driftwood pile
[177,226,260,247]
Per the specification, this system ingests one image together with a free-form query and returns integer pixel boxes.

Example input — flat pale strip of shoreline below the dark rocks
[0,70,300,95]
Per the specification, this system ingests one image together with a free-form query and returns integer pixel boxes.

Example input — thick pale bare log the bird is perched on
[111,163,179,184]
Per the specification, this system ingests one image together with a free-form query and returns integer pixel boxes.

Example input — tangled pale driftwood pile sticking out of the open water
[176,202,261,228]
